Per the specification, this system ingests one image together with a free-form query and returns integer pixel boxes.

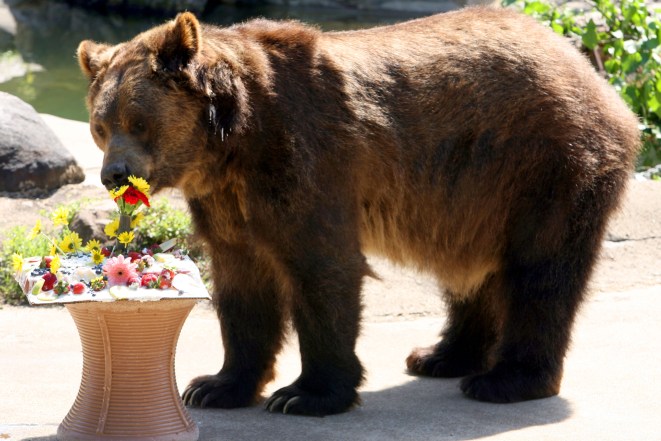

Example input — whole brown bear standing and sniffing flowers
[78,8,639,415]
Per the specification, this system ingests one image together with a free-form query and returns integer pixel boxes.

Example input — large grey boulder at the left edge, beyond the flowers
[0,92,85,196]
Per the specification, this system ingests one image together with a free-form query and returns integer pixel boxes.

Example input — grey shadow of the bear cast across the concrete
[190,378,571,441]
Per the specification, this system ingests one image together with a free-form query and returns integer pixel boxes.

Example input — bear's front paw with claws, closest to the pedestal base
[181,374,257,409]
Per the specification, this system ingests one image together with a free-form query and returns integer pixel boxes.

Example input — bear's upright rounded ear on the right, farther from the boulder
[156,12,202,72]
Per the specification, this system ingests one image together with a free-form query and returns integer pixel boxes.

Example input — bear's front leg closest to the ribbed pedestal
[182,242,283,408]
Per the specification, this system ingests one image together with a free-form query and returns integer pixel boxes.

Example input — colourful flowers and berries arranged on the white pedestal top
[12,176,208,301]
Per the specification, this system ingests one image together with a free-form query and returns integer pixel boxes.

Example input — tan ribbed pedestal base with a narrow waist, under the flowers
[57,299,198,441]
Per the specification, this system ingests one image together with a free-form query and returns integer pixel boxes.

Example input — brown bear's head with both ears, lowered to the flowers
[78,13,247,194]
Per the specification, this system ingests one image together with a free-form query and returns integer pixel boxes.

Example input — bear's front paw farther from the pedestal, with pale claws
[265,383,359,416]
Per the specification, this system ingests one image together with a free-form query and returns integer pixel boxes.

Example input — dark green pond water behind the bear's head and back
[0,1,419,121]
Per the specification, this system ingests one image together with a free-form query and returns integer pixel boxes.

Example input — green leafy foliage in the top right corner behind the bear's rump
[503,0,661,168]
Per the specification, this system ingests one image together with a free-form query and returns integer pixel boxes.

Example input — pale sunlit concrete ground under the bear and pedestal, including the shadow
[0,117,661,441]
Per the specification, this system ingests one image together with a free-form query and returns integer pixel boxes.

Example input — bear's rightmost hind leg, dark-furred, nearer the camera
[461,217,601,403]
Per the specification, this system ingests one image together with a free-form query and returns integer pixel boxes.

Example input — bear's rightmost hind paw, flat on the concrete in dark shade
[461,369,561,403]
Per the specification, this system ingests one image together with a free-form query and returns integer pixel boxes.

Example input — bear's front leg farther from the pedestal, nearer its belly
[266,245,367,416]
